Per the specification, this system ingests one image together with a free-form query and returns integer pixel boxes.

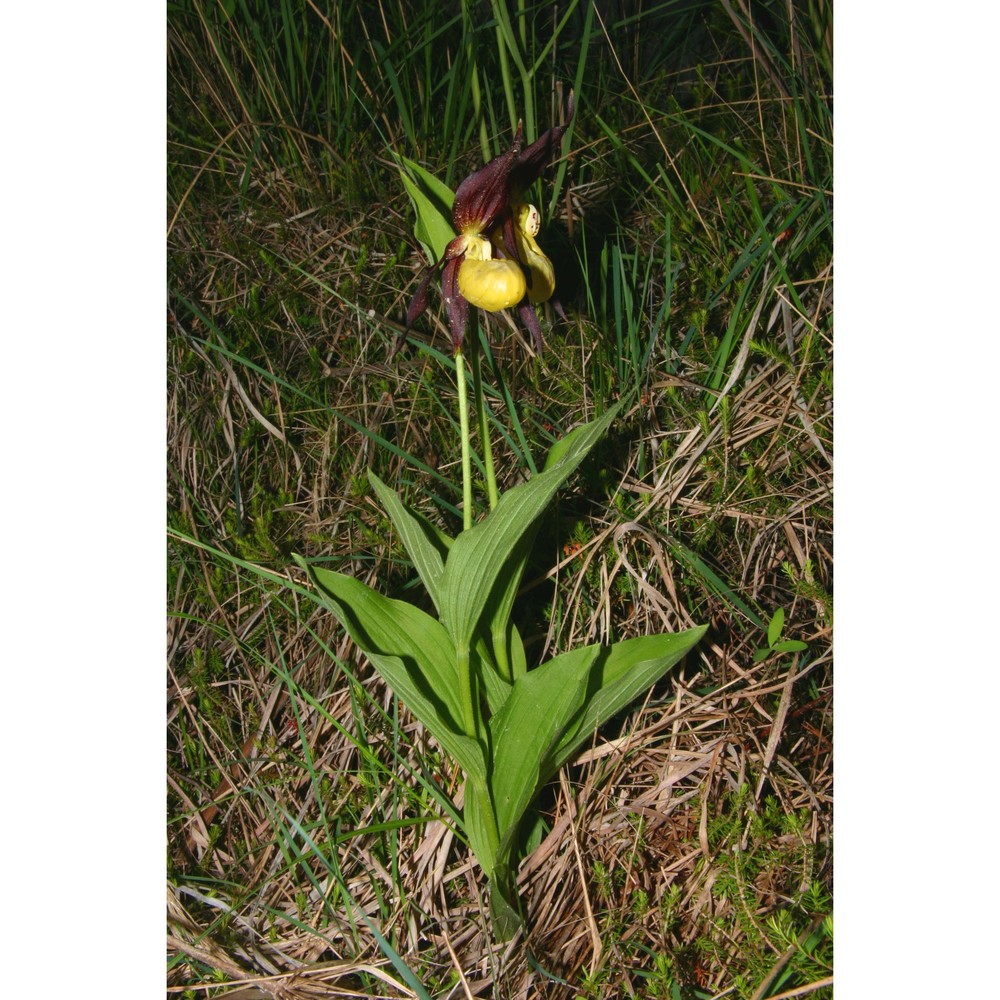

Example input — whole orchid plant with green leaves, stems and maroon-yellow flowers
[299,94,705,940]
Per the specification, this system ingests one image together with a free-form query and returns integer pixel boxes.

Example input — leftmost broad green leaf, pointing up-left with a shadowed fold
[295,556,486,786]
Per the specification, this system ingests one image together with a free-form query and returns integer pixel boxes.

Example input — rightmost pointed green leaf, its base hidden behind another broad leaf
[553,625,708,770]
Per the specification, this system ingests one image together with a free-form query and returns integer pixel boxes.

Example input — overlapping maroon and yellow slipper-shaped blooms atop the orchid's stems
[406,92,574,352]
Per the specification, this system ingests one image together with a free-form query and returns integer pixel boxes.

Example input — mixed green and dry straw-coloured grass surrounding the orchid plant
[168,0,833,1000]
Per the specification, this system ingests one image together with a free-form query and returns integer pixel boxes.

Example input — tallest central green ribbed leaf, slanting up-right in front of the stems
[438,406,618,647]
